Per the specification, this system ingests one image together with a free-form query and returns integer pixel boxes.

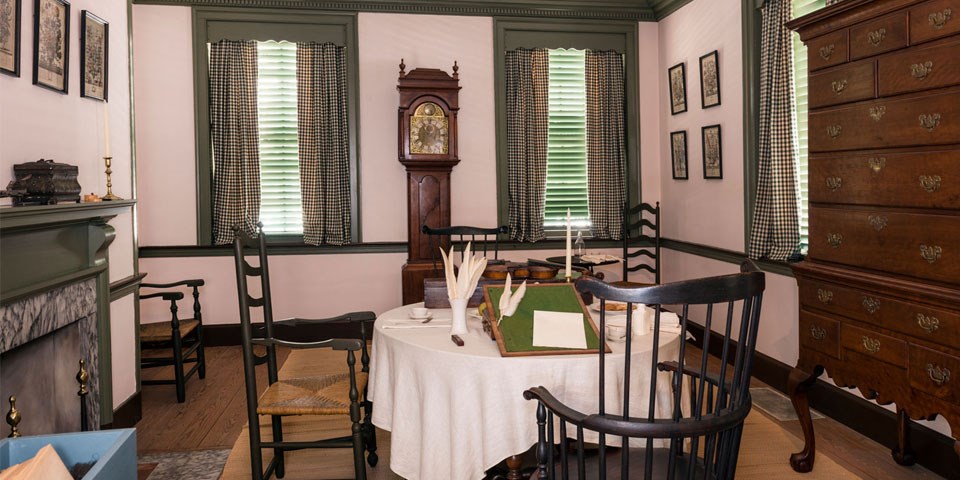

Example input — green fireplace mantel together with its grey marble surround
[0,200,136,429]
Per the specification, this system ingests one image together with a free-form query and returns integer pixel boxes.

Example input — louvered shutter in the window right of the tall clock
[543,49,590,230]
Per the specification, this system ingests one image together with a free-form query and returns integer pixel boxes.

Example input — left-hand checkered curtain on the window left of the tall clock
[210,40,260,245]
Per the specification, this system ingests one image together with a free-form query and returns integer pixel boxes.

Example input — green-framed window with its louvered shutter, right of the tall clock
[494,18,640,241]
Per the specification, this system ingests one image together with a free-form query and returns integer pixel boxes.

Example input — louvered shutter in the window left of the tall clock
[257,41,303,234]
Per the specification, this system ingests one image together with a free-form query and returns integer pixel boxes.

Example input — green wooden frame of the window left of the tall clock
[193,7,361,248]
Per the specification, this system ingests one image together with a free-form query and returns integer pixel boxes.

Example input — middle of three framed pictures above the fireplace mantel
[33,0,70,94]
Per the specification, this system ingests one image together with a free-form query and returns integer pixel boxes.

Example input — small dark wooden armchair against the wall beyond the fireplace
[140,279,207,403]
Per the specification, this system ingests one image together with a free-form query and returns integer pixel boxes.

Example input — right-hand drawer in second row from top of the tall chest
[876,37,960,96]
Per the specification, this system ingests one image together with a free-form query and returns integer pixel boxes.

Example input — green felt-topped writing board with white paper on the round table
[484,284,600,352]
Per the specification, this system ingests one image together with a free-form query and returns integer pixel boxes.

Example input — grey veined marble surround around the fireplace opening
[0,278,100,433]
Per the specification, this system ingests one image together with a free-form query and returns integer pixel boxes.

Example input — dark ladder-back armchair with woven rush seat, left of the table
[233,224,377,480]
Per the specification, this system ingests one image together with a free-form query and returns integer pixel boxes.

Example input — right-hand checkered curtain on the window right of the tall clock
[584,51,626,240]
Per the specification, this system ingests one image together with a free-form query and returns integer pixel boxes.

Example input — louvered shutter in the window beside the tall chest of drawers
[793,0,826,254]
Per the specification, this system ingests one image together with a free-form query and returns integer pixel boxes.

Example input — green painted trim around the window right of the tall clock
[493,18,641,240]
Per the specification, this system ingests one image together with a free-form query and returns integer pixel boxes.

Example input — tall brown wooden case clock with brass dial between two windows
[397,60,460,304]
